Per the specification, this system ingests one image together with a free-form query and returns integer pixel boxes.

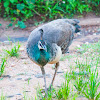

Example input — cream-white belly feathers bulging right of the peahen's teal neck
[49,43,62,64]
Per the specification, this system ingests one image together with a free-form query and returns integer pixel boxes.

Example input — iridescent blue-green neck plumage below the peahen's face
[32,45,50,66]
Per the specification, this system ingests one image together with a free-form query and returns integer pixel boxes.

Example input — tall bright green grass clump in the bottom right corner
[82,68,100,100]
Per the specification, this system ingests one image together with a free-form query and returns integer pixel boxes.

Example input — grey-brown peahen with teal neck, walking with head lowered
[27,19,80,94]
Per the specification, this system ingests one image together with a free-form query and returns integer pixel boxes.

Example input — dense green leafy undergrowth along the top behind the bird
[0,0,100,28]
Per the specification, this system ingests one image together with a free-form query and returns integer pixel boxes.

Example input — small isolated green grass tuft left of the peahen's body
[5,42,20,57]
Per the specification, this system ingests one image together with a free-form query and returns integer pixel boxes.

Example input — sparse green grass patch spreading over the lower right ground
[36,41,100,100]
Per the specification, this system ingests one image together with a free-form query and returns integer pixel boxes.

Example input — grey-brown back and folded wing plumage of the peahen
[28,19,79,53]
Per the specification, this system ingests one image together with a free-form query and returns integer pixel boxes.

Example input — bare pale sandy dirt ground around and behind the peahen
[0,18,100,100]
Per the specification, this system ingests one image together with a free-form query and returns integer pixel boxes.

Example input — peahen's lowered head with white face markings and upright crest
[38,29,47,52]
